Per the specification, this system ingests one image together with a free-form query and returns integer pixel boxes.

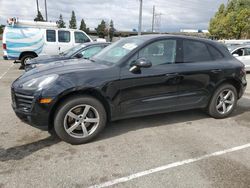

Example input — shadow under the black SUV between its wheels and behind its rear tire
[96,98,250,141]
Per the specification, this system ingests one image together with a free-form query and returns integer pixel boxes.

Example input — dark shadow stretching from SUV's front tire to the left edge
[0,136,60,162]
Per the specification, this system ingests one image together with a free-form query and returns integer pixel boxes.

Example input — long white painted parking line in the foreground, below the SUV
[89,143,250,188]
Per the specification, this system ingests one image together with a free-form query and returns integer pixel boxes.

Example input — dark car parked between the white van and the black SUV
[25,42,110,71]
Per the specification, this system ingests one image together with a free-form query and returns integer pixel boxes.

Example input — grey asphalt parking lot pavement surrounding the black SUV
[0,61,250,188]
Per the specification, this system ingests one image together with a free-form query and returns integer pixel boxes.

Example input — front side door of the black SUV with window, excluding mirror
[120,39,180,117]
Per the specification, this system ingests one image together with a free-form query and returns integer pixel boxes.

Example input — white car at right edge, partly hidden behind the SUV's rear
[230,45,250,71]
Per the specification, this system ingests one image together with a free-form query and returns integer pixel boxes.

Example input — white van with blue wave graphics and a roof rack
[3,18,92,64]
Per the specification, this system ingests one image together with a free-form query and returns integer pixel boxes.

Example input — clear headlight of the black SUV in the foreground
[22,74,58,90]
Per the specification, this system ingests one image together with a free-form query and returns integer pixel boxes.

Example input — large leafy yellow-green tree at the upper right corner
[209,0,250,39]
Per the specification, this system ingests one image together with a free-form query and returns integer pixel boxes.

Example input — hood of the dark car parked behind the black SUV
[27,55,69,65]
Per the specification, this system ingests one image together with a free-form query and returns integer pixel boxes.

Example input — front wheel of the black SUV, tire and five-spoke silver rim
[54,96,107,145]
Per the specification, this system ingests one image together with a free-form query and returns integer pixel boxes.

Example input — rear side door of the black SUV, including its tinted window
[178,39,227,109]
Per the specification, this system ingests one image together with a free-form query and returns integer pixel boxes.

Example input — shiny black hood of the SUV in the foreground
[19,59,109,79]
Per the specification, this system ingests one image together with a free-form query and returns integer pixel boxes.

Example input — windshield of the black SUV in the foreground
[91,37,145,64]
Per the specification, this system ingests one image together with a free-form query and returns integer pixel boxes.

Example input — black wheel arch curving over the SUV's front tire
[49,88,111,130]
